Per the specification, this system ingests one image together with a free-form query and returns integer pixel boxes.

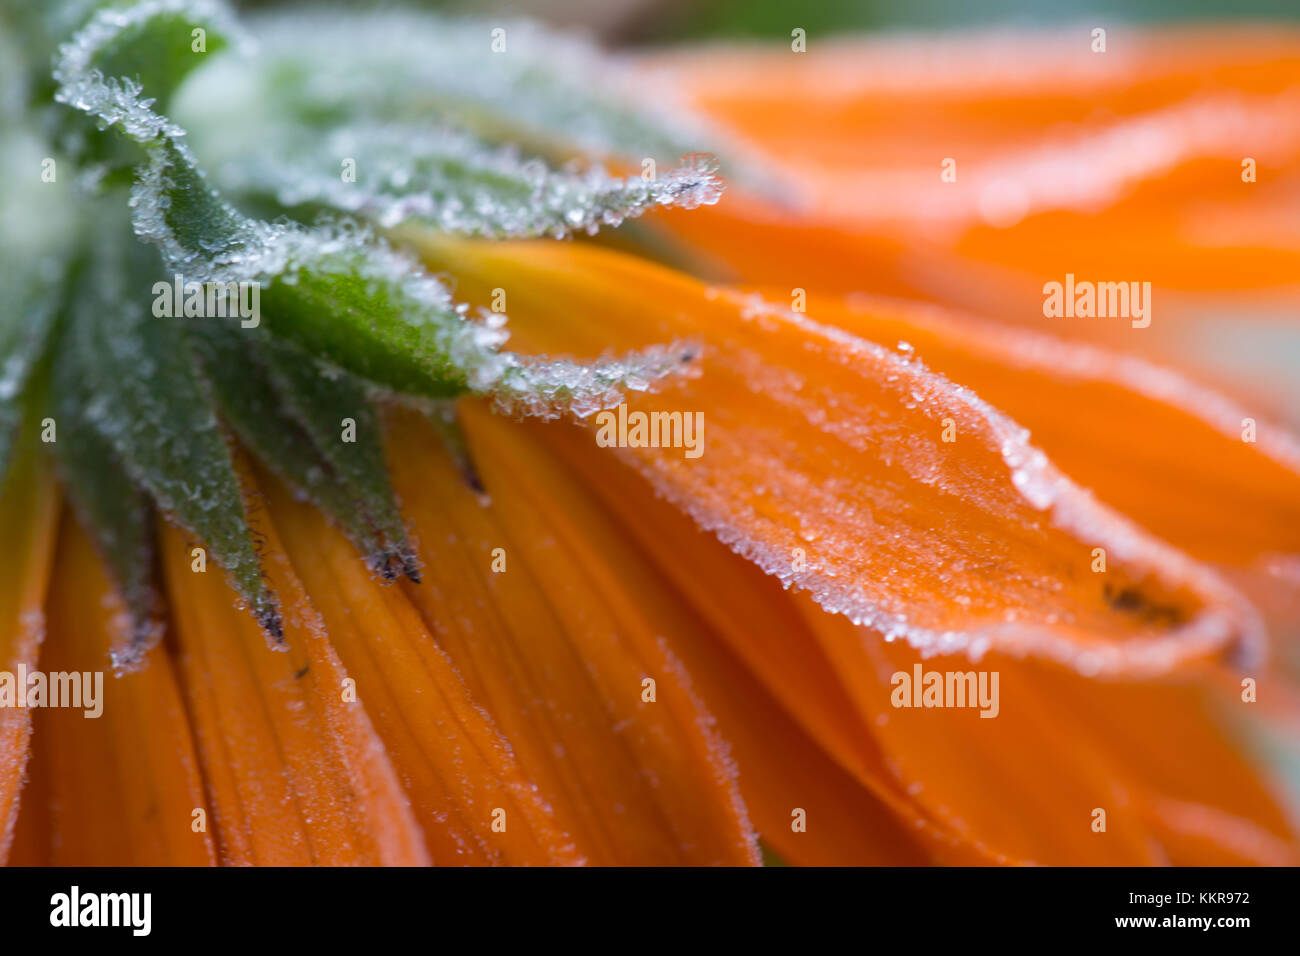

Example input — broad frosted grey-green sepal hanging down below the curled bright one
[64,207,282,639]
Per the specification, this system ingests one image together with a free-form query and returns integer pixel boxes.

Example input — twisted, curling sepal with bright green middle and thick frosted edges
[55,0,702,416]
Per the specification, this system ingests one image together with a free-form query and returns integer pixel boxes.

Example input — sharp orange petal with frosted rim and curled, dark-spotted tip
[410,243,1264,674]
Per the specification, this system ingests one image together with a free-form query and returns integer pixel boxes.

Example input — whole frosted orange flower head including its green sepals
[0,0,1300,865]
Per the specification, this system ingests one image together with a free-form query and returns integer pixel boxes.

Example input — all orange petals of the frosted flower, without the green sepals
[0,16,1300,865]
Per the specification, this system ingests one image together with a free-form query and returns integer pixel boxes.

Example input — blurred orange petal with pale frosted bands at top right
[650,27,1300,254]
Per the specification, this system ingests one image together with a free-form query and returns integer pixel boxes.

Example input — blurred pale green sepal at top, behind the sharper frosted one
[177,8,725,169]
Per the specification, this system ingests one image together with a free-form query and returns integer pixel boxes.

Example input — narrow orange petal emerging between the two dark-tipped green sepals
[254,463,582,864]
